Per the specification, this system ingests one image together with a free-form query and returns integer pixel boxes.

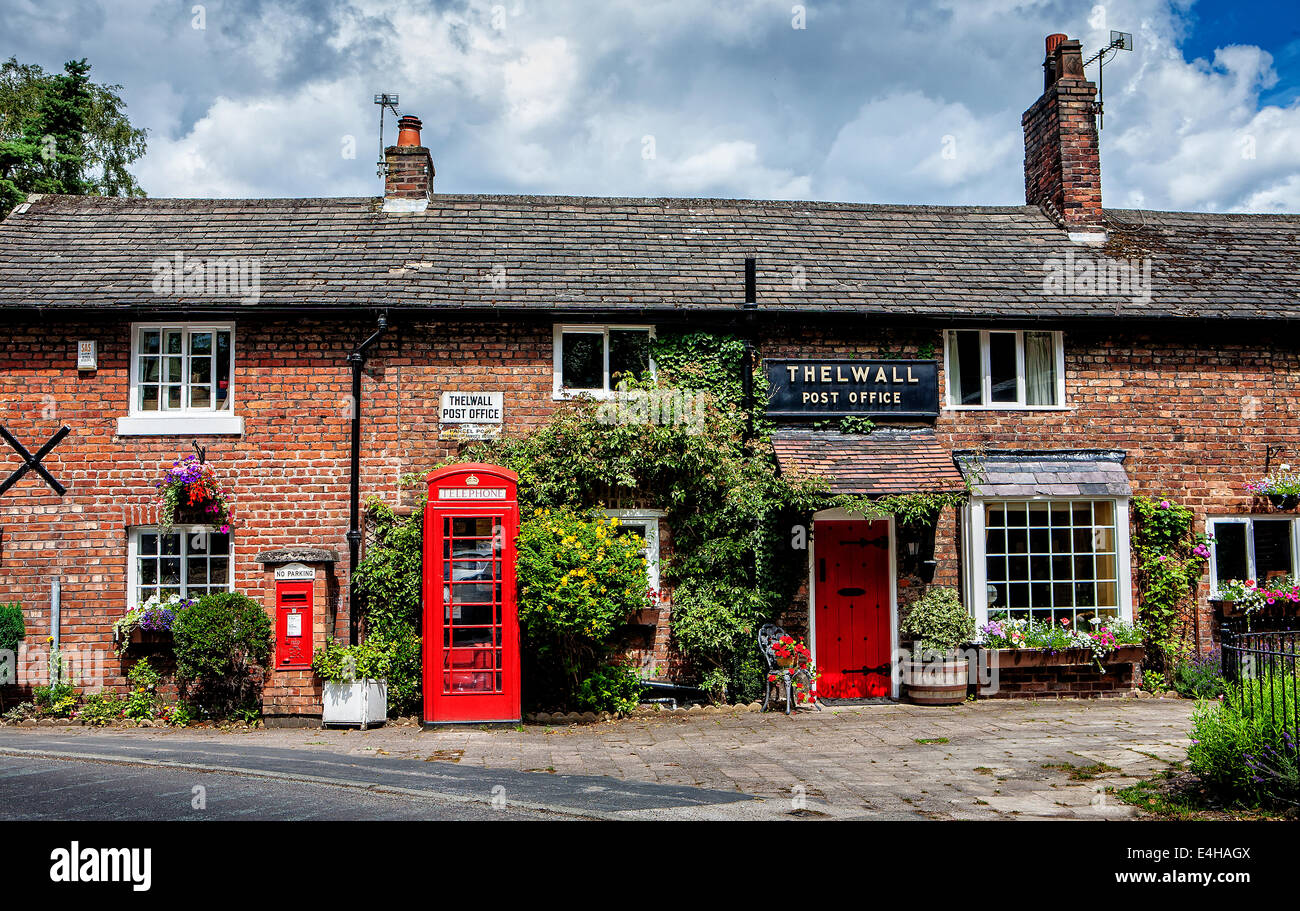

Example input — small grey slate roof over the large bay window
[953,450,1132,496]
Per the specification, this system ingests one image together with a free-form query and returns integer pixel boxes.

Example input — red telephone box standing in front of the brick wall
[424,464,521,724]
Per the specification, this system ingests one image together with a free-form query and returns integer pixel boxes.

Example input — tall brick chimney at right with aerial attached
[1021,35,1105,240]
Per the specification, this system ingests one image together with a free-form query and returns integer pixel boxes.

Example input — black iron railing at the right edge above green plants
[1219,617,1300,746]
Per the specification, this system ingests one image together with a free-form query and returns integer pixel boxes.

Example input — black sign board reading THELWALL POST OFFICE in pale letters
[763,359,939,417]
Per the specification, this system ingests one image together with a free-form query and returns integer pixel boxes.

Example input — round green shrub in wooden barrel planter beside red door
[900,586,975,706]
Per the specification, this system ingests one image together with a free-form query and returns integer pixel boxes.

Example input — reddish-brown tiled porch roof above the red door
[772,428,963,496]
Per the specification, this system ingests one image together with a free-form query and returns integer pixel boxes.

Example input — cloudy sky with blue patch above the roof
[0,0,1300,212]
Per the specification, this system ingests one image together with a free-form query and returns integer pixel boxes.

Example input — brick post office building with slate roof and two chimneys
[0,36,1300,713]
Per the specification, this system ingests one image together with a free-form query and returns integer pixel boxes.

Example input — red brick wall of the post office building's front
[0,318,1300,701]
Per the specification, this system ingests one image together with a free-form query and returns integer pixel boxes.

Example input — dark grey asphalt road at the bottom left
[0,730,759,820]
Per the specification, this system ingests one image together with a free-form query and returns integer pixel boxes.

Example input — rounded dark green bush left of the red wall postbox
[172,591,270,717]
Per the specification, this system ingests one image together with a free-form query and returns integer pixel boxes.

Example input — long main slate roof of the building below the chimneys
[0,194,1300,321]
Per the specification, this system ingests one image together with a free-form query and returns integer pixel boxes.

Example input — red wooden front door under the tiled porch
[813,520,892,699]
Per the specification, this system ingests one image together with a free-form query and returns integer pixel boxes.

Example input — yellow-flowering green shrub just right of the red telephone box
[517,509,650,704]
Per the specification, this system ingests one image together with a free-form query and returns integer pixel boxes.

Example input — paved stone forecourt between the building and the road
[0,699,1193,819]
